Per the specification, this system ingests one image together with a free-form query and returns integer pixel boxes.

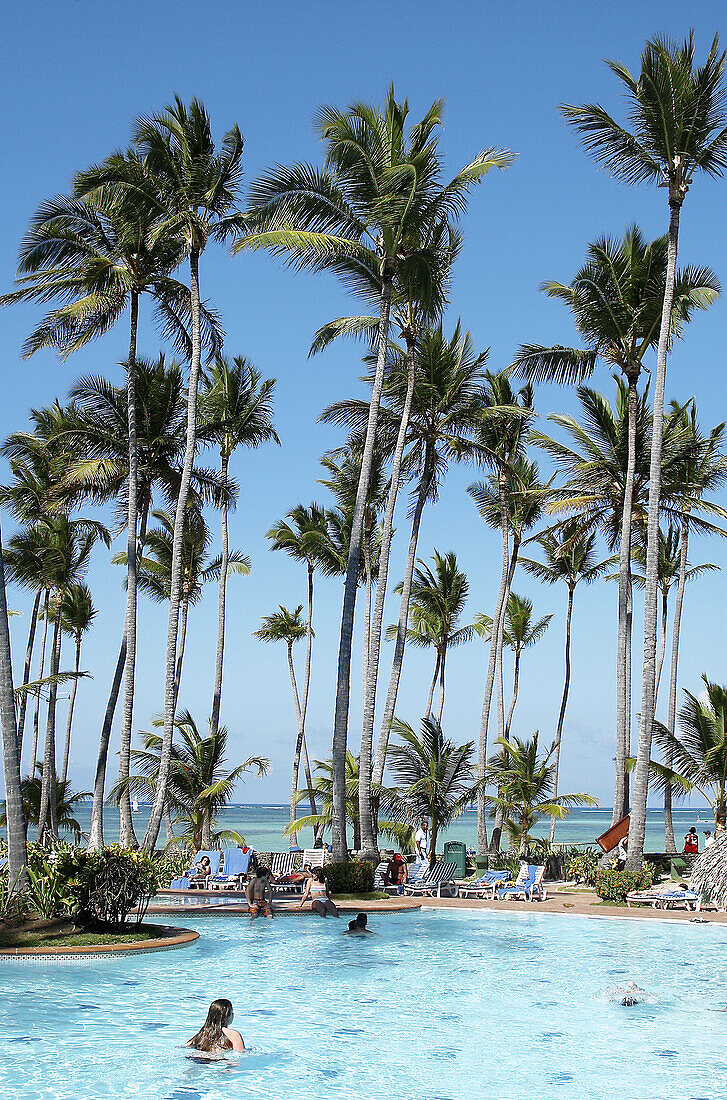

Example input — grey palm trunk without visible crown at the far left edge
[0,519,27,892]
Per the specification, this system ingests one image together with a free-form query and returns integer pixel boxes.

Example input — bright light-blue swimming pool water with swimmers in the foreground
[0,910,727,1100]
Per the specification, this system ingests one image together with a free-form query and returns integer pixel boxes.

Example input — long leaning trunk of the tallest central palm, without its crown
[331,262,394,861]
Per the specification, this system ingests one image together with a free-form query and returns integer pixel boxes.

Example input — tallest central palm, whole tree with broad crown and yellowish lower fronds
[235,86,513,859]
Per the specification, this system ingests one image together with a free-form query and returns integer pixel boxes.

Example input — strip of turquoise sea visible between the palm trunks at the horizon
[65,804,714,851]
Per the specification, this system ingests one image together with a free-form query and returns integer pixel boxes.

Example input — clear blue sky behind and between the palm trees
[0,0,727,804]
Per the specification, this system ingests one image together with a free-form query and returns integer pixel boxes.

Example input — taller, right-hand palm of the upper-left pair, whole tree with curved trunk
[84,97,243,850]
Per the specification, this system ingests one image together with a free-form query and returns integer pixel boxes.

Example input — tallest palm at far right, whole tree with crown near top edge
[561,32,727,870]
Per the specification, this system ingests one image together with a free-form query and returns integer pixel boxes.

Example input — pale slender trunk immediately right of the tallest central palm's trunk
[359,340,416,859]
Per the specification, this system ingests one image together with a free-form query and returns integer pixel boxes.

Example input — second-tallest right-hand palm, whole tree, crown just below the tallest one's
[513,226,719,823]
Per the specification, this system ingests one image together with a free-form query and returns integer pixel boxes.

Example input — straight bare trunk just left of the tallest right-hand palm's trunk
[612,374,639,825]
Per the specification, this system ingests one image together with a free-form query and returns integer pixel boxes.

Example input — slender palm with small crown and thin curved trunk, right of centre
[520,519,607,844]
